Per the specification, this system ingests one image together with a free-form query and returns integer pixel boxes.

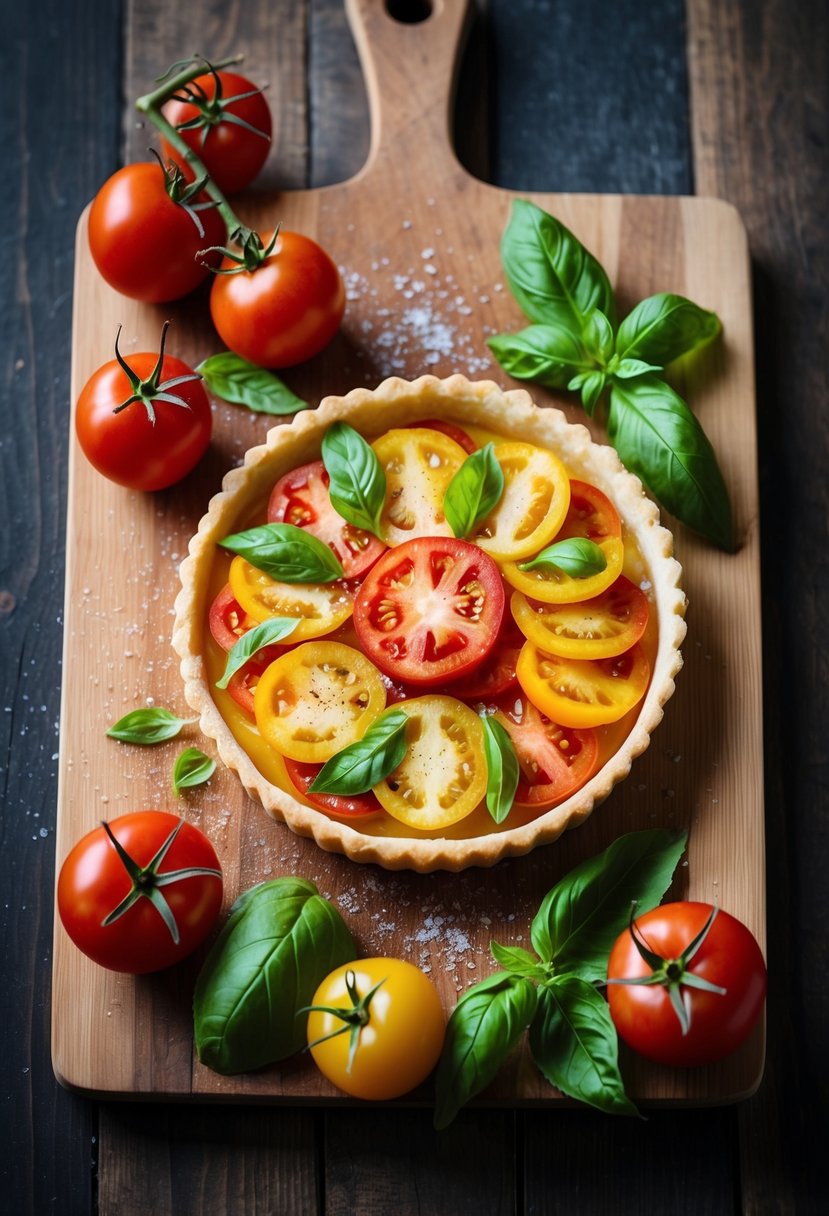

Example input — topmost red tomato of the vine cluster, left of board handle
[162,72,271,195]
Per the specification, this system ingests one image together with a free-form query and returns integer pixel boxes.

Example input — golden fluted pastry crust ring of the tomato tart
[173,375,686,873]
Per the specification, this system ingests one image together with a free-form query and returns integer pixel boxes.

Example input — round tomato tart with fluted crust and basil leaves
[173,376,686,872]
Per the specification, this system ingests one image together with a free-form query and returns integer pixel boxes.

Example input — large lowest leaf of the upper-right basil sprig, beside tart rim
[608,373,734,550]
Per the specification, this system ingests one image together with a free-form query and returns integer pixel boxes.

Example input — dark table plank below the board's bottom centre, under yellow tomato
[323,1109,517,1216]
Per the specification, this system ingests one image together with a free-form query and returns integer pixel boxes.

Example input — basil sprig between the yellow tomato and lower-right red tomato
[434,828,687,1127]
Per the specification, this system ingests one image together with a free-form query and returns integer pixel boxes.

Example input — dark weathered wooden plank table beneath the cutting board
[0,0,829,1216]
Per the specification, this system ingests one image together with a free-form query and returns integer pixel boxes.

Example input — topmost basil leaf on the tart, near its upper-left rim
[322,422,385,540]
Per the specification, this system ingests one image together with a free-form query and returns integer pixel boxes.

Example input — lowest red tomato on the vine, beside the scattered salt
[210,229,345,367]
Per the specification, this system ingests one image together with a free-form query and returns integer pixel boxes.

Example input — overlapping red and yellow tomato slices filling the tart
[209,422,650,831]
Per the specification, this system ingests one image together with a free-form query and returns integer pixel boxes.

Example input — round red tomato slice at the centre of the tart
[354,536,504,688]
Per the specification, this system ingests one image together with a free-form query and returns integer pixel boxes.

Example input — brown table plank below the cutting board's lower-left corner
[97,1105,318,1216]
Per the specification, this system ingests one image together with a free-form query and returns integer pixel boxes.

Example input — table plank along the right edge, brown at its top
[688,0,829,1212]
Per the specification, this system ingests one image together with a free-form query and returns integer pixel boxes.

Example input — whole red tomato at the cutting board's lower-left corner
[57,811,222,975]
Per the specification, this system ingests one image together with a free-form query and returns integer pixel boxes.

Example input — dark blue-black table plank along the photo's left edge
[0,2,119,1216]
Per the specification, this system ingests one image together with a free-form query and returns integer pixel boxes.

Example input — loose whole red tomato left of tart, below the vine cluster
[75,323,213,490]
